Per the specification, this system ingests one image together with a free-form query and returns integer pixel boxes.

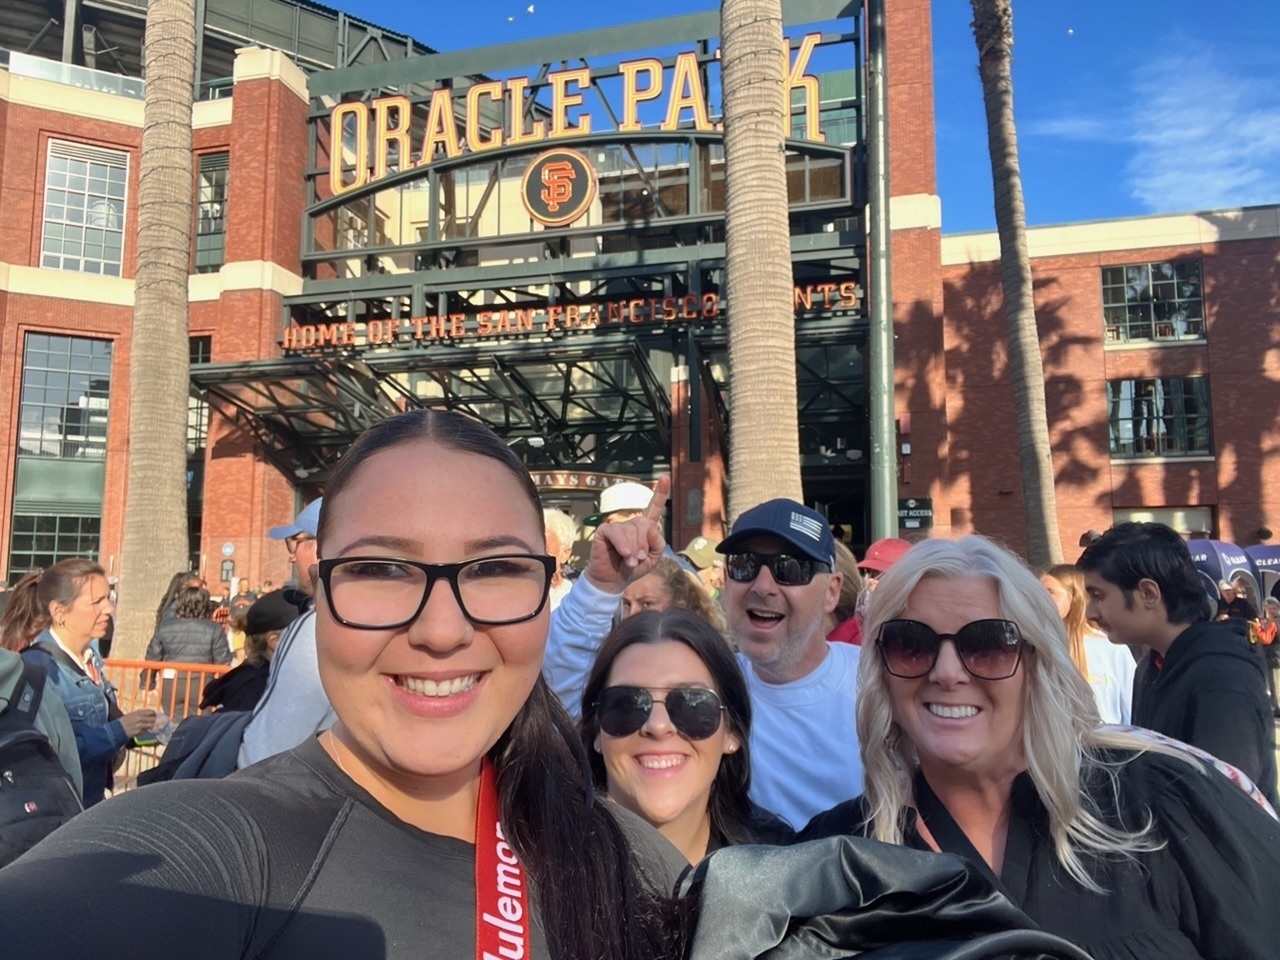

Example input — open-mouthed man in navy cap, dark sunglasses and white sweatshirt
[717,499,863,829]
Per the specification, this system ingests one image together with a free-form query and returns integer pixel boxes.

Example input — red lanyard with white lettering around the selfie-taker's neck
[476,756,532,960]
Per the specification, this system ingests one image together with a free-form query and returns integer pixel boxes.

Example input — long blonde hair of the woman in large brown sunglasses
[858,536,1202,892]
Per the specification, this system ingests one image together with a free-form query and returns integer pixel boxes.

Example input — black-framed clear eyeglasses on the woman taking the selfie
[317,553,556,630]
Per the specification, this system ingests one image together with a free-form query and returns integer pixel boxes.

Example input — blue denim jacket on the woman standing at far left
[22,630,129,808]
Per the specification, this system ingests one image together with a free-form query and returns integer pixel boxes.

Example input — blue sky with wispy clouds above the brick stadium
[335,0,1280,233]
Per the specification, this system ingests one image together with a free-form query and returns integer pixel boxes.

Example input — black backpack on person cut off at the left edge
[0,660,83,867]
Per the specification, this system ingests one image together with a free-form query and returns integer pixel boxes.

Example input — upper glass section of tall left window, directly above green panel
[18,333,111,460]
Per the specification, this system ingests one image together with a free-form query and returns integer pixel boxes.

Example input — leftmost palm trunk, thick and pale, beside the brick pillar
[115,0,198,658]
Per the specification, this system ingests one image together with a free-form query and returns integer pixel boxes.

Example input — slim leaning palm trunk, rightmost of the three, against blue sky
[970,0,1062,566]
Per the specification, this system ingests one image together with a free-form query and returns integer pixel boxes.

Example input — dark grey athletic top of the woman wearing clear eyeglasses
[0,740,687,960]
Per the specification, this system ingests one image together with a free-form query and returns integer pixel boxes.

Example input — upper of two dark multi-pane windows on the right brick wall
[1102,260,1204,343]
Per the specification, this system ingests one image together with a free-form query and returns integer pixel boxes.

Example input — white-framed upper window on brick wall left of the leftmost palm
[40,140,129,276]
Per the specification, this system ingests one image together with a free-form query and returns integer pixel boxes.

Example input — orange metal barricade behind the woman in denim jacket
[105,659,230,794]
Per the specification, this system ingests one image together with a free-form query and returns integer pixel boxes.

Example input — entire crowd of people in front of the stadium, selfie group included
[0,411,1280,960]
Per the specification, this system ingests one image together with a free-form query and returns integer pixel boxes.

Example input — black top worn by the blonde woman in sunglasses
[800,753,1280,960]
